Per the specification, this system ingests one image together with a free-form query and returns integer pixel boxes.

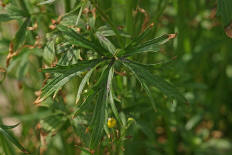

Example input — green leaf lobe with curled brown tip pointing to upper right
[122,34,176,57]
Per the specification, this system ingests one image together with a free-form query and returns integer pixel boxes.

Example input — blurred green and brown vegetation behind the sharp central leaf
[0,0,232,155]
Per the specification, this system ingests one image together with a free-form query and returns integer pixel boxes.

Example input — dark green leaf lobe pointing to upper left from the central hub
[57,25,105,55]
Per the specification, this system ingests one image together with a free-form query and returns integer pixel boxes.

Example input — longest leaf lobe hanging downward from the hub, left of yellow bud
[90,65,113,148]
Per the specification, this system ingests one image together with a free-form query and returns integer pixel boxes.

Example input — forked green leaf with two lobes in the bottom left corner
[0,124,29,153]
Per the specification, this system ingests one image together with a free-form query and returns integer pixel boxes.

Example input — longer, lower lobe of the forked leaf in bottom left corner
[0,127,29,153]
